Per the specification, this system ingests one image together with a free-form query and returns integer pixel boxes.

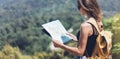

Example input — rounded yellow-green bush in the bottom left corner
[0,44,22,59]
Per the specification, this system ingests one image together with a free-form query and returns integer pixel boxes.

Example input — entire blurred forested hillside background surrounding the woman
[0,0,120,59]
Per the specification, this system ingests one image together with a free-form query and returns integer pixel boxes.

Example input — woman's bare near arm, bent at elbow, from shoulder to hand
[53,23,91,56]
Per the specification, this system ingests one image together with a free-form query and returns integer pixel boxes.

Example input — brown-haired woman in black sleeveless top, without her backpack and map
[53,0,102,59]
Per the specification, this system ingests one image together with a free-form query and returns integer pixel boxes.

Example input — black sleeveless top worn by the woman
[77,23,98,57]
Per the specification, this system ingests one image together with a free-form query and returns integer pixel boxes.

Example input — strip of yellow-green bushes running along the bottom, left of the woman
[0,44,76,59]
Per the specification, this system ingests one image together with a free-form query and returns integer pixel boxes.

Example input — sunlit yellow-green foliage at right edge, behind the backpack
[103,14,120,59]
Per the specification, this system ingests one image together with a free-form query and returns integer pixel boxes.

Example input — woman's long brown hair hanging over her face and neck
[77,0,102,20]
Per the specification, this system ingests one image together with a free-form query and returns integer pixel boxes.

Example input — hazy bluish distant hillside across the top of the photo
[0,0,120,25]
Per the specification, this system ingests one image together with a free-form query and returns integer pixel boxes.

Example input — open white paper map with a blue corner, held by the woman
[42,20,71,49]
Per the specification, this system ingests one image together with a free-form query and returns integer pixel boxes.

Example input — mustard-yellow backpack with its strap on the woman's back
[87,18,112,59]
